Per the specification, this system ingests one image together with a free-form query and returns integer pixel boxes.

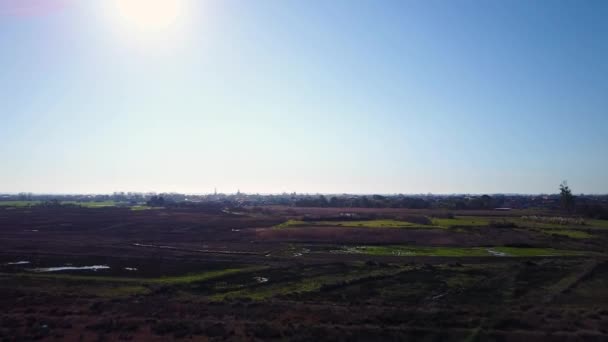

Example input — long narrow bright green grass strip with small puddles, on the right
[337,246,590,257]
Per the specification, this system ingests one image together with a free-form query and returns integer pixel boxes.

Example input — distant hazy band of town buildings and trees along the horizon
[0,191,608,218]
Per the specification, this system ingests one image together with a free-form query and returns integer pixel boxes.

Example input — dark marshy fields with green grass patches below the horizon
[0,196,608,341]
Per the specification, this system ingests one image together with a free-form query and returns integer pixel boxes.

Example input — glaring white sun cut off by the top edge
[114,0,184,32]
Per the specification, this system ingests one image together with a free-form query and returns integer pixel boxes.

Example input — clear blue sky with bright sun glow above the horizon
[0,0,608,194]
